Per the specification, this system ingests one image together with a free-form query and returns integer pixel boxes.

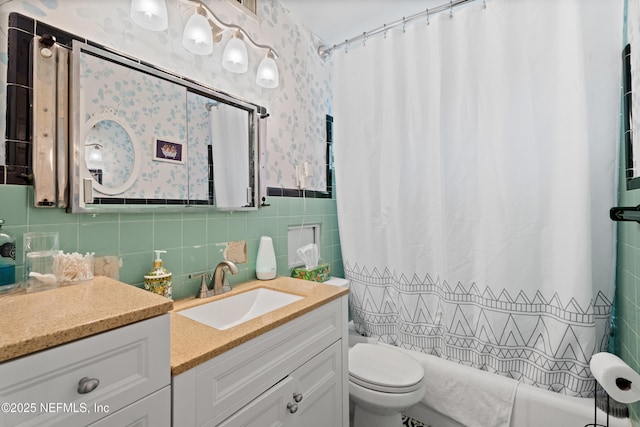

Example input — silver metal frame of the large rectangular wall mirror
[69,40,262,213]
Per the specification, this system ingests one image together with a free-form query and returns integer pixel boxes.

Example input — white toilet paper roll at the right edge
[589,353,640,403]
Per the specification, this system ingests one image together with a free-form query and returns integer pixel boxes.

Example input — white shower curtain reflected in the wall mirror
[209,103,249,209]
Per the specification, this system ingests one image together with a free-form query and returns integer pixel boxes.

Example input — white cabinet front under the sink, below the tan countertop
[173,296,349,427]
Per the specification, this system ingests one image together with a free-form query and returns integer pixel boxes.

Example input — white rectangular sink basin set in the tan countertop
[177,288,303,330]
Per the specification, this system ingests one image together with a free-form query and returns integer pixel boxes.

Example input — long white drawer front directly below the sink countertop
[173,300,346,426]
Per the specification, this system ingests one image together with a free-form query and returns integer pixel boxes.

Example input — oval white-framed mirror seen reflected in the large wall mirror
[84,117,140,195]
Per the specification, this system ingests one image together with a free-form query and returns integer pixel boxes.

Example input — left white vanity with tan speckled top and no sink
[0,277,173,426]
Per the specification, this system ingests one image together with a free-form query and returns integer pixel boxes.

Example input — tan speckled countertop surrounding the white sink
[171,277,349,375]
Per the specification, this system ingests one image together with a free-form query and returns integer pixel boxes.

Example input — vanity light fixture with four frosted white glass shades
[131,0,280,89]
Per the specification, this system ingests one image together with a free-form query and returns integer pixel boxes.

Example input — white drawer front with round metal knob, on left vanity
[0,314,170,427]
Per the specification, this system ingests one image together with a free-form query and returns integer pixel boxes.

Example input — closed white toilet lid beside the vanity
[349,343,424,393]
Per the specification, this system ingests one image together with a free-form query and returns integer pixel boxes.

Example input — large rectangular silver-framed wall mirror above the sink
[70,41,267,212]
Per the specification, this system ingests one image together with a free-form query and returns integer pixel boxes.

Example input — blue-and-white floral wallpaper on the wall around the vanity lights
[0,0,332,190]
